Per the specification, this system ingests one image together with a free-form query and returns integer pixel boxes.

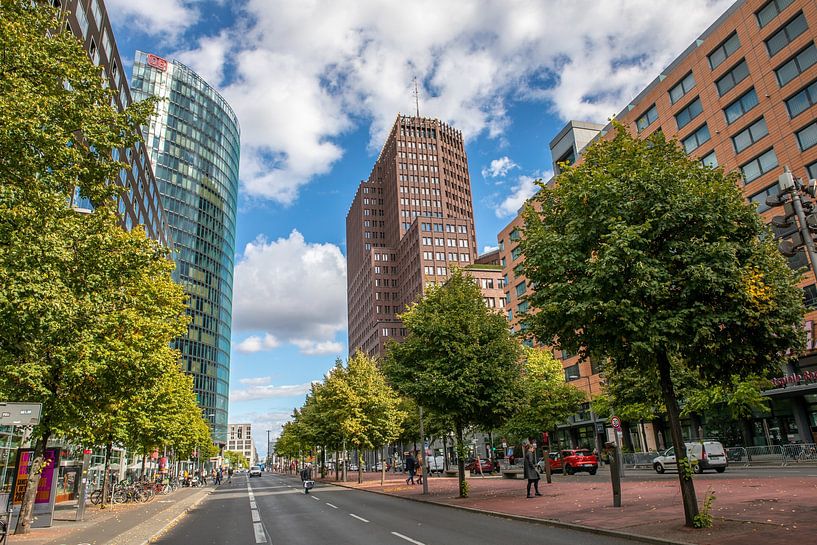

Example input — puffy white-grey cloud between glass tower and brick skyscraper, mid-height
[233,230,346,354]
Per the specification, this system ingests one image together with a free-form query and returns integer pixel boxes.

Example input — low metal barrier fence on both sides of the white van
[624,443,817,468]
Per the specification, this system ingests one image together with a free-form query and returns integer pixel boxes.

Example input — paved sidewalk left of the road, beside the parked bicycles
[7,486,215,545]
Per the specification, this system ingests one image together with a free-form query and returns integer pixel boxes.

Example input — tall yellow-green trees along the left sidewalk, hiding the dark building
[0,0,212,533]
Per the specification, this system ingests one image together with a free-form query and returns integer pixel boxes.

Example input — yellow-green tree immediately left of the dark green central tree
[324,350,406,482]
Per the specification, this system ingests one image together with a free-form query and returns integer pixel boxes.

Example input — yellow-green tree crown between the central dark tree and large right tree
[502,348,585,442]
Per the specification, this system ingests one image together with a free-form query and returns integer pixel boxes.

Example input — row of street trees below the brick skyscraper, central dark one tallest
[276,270,584,497]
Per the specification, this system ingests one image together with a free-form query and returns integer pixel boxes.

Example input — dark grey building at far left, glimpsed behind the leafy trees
[61,0,170,245]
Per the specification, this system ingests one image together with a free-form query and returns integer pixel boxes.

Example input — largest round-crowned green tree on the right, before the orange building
[522,125,803,526]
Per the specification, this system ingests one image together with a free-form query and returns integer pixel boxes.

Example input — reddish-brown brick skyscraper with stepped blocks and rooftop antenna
[346,115,477,356]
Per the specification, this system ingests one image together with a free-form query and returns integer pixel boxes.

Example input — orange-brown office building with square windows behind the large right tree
[498,0,817,445]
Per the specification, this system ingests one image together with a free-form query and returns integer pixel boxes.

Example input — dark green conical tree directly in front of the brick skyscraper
[383,269,521,497]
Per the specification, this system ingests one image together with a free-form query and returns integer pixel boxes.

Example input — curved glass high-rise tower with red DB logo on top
[132,51,239,444]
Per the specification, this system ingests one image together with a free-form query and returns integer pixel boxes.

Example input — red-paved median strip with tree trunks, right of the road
[324,469,817,545]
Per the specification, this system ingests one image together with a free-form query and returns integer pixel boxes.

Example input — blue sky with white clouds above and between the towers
[105,0,731,455]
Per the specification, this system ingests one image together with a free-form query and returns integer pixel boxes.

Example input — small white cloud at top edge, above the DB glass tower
[105,0,199,36]
